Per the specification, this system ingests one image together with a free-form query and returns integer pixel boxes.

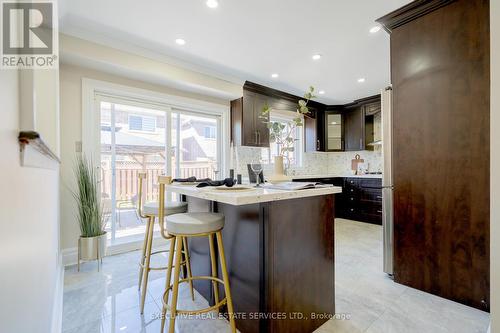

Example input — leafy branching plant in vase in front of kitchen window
[259,86,316,181]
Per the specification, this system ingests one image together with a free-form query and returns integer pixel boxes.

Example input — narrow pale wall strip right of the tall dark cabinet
[490,0,500,333]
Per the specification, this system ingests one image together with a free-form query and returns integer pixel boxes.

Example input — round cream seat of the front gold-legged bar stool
[166,213,224,235]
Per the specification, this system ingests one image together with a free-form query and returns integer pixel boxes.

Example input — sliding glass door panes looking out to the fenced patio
[98,98,221,243]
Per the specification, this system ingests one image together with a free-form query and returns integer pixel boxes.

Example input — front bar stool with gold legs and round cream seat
[158,176,236,333]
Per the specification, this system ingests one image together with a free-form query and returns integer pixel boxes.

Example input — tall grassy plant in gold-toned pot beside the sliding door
[73,156,107,267]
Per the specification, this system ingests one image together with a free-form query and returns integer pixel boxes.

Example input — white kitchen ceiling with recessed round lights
[59,0,410,104]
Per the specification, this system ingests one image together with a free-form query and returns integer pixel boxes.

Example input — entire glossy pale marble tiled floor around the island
[63,219,489,333]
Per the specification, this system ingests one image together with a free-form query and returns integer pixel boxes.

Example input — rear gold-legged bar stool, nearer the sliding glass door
[137,172,194,314]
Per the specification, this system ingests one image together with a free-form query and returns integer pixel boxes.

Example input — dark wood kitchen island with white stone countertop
[167,185,342,333]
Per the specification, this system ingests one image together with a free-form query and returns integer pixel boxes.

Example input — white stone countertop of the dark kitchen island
[166,184,342,206]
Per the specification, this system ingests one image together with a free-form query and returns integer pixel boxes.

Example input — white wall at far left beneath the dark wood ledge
[0,70,62,333]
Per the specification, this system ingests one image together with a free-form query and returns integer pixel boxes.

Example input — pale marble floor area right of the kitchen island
[316,219,489,333]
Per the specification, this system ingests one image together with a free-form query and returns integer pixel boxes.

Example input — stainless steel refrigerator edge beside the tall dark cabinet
[381,87,394,275]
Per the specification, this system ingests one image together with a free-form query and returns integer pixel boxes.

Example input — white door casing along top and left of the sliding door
[60,63,229,256]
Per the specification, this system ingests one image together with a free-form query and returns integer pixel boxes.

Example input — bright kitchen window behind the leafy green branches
[261,111,304,166]
